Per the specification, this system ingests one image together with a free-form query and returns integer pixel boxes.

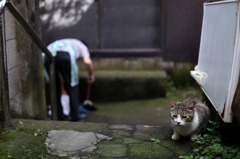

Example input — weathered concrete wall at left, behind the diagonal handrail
[5,0,46,119]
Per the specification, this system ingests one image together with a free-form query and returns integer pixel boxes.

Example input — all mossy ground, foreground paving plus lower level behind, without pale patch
[0,91,201,159]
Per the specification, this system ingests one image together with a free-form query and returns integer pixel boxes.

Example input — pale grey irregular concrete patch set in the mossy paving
[45,130,111,157]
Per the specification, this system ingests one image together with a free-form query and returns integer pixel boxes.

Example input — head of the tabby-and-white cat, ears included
[169,100,195,126]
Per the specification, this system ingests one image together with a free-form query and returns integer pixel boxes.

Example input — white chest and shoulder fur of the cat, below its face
[173,111,199,136]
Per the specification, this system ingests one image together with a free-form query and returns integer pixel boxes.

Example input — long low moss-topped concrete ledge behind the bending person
[79,71,167,101]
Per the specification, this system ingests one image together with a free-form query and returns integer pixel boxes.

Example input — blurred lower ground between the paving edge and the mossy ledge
[83,98,169,126]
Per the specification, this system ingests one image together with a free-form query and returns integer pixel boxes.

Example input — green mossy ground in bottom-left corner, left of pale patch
[0,129,66,159]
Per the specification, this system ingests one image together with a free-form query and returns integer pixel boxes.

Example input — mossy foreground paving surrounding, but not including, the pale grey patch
[0,119,192,159]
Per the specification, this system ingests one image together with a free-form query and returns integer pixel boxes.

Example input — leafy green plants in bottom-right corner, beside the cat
[179,121,240,159]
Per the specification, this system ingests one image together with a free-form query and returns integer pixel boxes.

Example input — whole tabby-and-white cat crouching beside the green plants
[169,97,210,140]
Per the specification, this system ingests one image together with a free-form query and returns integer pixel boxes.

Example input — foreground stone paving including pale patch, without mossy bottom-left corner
[12,119,192,159]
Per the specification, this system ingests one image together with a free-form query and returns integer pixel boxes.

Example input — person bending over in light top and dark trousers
[45,39,95,121]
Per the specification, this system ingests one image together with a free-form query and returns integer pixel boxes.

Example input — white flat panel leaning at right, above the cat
[196,0,238,113]
